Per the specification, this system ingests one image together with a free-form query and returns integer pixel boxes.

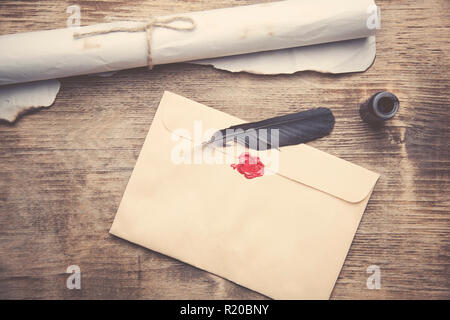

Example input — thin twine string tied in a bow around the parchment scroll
[73,16,197,70]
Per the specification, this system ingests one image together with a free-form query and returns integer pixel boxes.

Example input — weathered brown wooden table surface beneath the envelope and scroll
[0,0,450,299]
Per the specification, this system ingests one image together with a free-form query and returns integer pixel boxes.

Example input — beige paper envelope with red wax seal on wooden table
[110,92,379,299]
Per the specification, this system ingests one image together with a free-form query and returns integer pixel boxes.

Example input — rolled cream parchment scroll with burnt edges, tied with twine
[0,0,379,85]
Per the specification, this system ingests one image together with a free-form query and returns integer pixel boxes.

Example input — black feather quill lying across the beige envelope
[206,108,334,150]
